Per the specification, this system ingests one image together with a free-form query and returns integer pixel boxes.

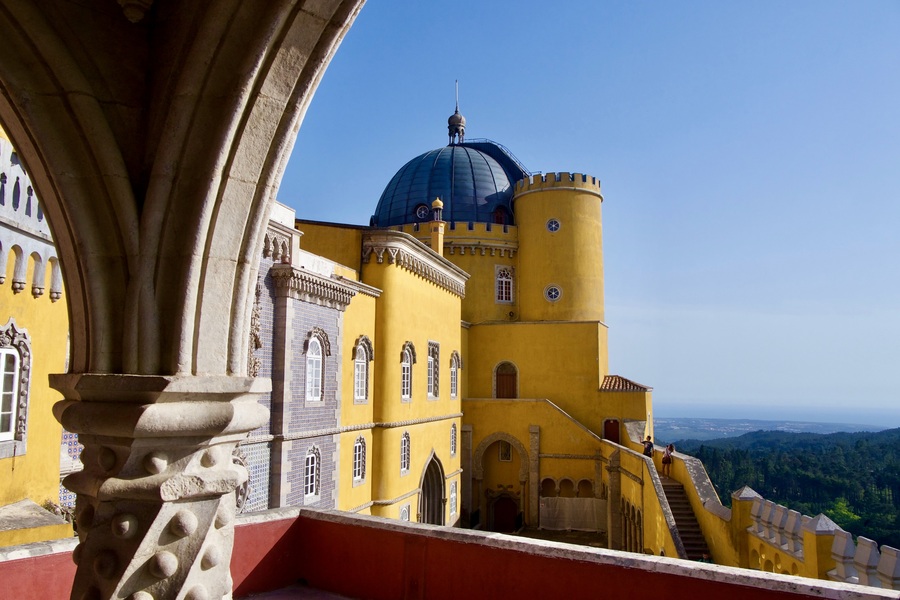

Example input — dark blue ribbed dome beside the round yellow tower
[372,140,528,227]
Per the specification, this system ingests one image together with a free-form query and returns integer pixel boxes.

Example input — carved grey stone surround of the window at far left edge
[0,318,31,458]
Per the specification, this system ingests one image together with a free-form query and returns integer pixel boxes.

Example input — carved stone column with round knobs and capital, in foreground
[51,374,269,600]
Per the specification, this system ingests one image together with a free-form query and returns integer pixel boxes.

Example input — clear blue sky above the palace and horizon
[279,0,900,427]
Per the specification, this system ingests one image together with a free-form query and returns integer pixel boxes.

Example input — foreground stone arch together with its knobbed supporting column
[0,0,370,597]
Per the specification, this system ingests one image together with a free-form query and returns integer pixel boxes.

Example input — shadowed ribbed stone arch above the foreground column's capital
[0,0,360,375]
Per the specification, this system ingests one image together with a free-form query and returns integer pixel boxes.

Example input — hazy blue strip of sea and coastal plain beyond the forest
[653,402,900,431]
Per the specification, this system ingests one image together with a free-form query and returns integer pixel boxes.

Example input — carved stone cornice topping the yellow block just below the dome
[362,230,469,298]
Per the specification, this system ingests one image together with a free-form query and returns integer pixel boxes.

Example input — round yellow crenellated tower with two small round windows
[513,173,604,321]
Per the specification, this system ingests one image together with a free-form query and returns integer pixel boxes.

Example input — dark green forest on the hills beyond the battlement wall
[677,429,900,548]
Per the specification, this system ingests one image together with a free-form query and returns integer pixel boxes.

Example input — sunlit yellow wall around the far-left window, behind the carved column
[0,252,72,546]
